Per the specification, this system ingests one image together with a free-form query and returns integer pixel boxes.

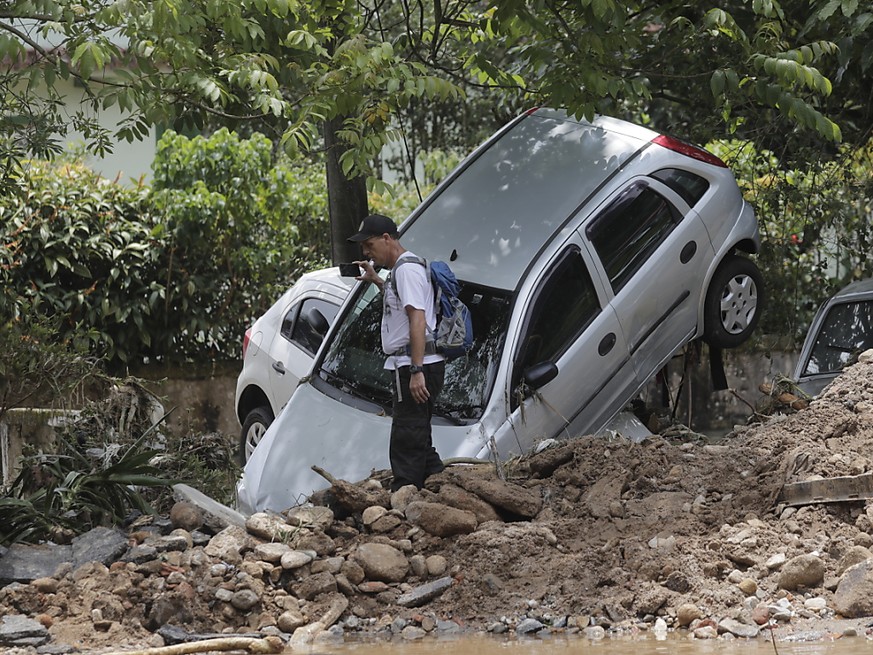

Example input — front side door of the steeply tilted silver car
[510,238,636,448]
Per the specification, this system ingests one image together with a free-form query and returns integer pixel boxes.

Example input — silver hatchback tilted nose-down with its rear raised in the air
[238,109,763,511]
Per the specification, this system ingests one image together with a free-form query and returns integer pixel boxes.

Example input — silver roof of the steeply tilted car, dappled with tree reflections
[400,109,658,290]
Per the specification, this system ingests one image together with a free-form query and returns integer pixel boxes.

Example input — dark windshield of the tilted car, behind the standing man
[319,271,510,423]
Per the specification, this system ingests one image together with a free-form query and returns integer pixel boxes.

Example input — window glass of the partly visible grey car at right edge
[803,301,873,375]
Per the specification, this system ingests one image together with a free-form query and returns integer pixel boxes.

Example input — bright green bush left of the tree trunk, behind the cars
[151,129,329,358]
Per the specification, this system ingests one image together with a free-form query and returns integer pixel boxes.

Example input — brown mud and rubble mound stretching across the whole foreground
[0,357,873,651]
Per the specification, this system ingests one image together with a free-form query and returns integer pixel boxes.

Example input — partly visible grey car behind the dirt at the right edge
[794,278,873,396]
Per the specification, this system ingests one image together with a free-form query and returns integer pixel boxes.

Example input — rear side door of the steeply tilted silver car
[584,177,714,384]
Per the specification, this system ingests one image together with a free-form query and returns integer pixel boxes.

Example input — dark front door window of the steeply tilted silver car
[516,246,600,375]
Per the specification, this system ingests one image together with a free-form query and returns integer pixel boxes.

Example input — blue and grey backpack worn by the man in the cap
[394,257,473,361]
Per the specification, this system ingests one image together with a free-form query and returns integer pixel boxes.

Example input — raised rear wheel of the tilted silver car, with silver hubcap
[703,255,764,348]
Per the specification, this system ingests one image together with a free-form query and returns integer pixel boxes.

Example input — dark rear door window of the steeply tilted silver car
[585,182,681,293]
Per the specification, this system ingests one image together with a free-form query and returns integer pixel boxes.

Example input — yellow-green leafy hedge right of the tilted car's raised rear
[708,141,873,344]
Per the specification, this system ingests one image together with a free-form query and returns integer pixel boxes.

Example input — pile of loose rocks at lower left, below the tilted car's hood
[0,471,541,652]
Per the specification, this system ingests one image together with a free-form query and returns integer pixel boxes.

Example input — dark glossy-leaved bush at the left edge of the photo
[0,161,163,362]
